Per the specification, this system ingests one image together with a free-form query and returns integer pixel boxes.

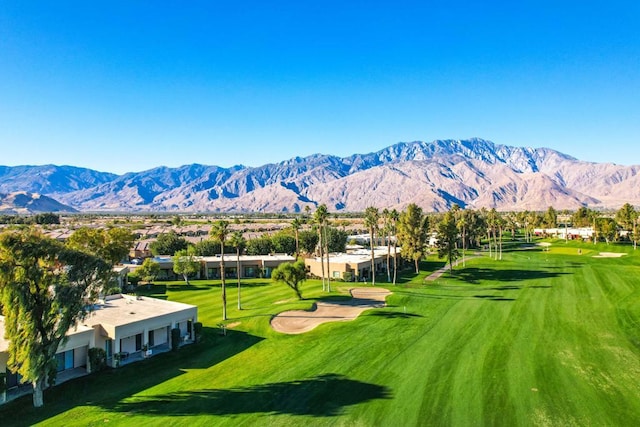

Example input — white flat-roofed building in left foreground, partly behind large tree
[0,294,198,402]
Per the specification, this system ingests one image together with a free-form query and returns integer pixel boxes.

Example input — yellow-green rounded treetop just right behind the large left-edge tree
[66,227,135,265]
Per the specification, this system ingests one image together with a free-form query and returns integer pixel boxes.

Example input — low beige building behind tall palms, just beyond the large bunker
[304,246,401,281]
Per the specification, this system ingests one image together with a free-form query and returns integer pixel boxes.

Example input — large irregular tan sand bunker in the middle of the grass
[271,288,391,334]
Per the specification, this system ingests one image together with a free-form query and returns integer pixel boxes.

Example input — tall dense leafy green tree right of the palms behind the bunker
[398,203,429,274]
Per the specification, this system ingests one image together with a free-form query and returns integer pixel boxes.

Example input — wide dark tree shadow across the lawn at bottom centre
[108,374,391,417]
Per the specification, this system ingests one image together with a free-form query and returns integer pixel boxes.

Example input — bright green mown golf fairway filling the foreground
[0,241,640,426]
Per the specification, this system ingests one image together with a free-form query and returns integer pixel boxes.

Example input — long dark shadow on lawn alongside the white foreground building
[0,327,263,426]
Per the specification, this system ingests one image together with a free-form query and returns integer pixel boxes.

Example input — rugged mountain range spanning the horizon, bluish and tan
[0,138,640,212]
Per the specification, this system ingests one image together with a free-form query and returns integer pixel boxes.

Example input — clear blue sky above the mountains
[0,0,640,173]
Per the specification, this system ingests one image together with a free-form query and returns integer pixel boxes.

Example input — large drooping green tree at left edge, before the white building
[0,229,111,407]
